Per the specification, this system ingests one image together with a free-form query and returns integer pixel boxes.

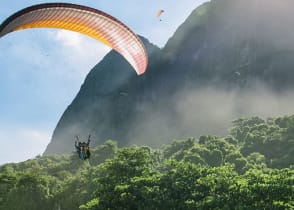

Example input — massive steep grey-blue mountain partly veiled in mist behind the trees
[44,0,294,154]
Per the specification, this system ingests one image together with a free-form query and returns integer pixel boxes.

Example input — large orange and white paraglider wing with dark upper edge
[0,3,148,74]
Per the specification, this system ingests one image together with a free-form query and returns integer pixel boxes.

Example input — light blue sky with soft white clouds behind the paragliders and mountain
[0,0,206,165]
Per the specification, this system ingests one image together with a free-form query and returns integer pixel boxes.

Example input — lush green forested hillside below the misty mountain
[0,115,294,210]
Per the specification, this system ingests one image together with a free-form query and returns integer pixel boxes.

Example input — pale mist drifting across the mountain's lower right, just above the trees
[128,82,294,147]
